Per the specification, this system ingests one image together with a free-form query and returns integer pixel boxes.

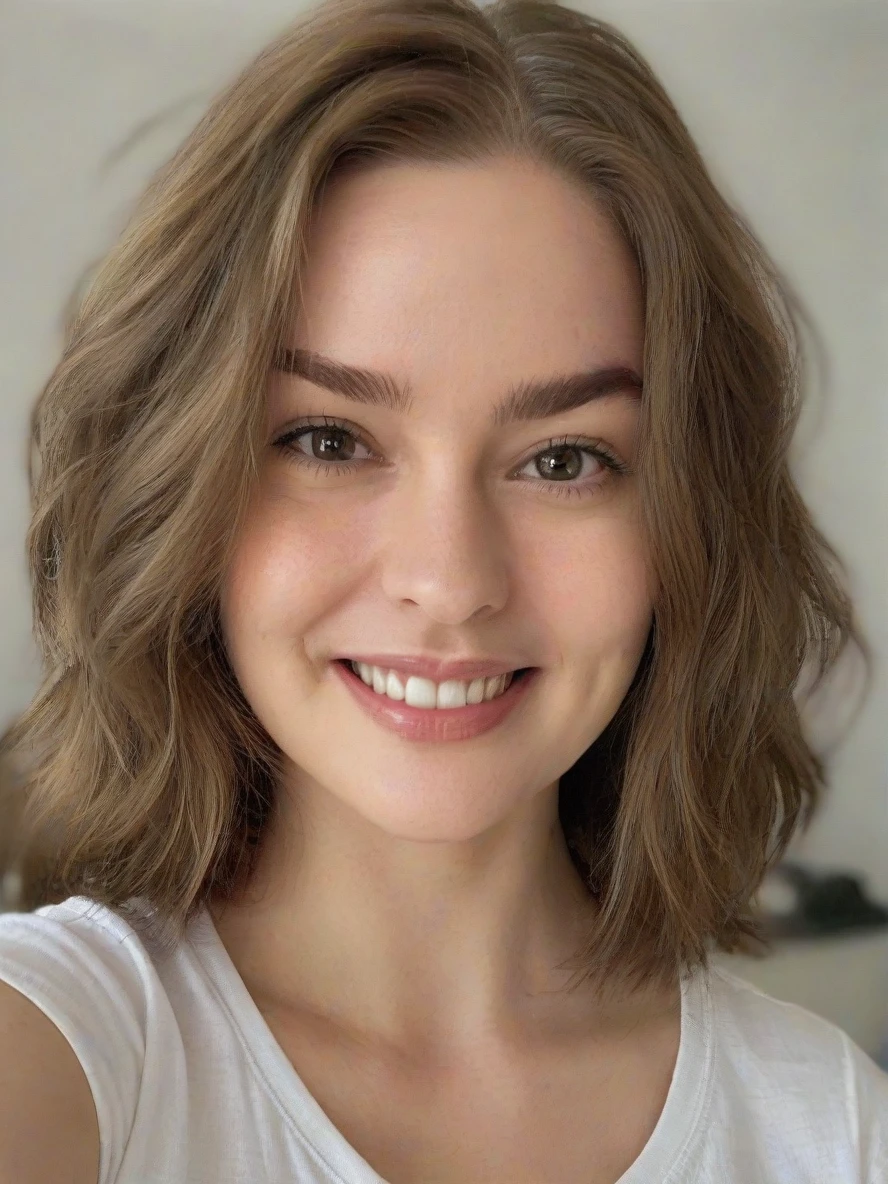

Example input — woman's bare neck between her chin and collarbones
[211,785,677,1053]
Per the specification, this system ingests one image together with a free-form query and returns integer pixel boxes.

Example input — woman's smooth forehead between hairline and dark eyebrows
[275,161,644,428]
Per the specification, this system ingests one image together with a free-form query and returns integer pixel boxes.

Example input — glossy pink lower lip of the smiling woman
[333,661,540,740]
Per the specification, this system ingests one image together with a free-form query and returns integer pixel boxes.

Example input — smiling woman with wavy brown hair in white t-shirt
[0,0,888,1184]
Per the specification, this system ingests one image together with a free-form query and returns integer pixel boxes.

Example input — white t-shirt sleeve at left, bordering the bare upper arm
[0,905,146,1184]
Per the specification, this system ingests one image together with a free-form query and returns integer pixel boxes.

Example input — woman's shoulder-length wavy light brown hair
[1,0,870,999]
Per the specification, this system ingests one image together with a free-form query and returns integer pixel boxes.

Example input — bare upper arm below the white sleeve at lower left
[0,982,99,1184]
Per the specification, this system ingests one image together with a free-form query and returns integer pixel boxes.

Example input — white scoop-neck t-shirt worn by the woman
[0,896,888,1184]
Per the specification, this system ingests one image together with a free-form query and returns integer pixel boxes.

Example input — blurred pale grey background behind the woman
[0,0,888,1068]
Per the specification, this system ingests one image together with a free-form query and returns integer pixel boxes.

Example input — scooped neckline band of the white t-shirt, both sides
[187,906,714,1184]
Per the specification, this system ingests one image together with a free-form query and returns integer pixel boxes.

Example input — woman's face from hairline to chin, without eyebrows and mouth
[223,160,654,841]
